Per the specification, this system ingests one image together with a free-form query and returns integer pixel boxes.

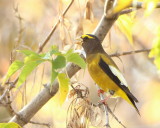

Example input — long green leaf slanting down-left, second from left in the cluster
[17,61,43,87]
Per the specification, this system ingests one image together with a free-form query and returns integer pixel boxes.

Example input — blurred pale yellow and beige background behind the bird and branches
[0,0,160,128]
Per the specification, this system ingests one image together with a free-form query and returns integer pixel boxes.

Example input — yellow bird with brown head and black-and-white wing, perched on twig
[81,34,140,115]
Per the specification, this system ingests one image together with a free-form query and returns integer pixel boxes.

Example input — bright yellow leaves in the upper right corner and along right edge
[113,0,160,69]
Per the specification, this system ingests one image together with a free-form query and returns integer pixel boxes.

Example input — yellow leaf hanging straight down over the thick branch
[58,73,69,105]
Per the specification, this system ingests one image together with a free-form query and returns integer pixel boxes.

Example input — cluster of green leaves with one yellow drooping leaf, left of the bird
[3,46,86,104]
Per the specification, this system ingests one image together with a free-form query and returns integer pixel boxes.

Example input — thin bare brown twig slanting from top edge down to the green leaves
[38,0,74,53]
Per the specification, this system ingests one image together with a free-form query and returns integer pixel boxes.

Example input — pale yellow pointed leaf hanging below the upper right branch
[116,15,133,44]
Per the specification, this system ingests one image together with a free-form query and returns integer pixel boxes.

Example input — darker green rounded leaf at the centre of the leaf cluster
[52,55,66,69]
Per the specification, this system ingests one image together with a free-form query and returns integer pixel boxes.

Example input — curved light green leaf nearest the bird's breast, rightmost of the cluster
[66,53,86,69]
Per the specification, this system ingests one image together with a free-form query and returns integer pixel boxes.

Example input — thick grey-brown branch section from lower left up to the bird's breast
[9,63,80,126]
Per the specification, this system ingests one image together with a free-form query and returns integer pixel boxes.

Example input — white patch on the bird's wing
[109,65,128,87]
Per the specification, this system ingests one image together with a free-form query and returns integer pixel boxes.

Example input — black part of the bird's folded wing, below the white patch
[99,58,138,105]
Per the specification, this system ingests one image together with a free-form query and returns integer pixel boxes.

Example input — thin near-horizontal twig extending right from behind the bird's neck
[109,49,151,57]
